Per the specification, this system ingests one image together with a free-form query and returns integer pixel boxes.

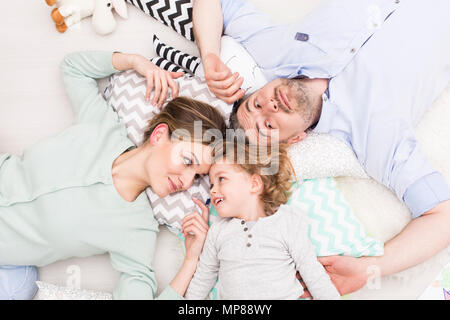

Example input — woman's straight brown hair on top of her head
[144,97,226,144]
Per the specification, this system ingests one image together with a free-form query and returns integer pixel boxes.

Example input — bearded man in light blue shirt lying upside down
[193,0,450,294]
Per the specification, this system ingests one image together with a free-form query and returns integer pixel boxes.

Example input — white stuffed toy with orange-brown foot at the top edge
[45,0,128,35]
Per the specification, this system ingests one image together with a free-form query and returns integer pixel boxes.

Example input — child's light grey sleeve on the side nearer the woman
[185,223,219,300]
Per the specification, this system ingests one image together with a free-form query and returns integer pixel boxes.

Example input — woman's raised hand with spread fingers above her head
[132,55,184,108]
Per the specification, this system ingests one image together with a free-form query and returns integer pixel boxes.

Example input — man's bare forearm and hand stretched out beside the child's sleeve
[319,200,450,294]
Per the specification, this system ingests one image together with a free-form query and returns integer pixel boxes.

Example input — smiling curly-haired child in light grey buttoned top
[183,143,340,300]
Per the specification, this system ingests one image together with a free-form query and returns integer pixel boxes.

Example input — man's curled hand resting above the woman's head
[203,53,245,104]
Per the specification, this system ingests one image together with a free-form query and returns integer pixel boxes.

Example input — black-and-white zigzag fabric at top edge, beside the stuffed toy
[126,0,194,41]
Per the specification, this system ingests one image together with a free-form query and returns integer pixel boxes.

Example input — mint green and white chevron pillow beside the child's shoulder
[288,178,384,257]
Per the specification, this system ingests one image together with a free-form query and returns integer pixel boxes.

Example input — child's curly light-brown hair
[214,140,296,215]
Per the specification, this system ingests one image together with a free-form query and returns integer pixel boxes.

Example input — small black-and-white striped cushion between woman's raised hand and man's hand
[153,35,202,74]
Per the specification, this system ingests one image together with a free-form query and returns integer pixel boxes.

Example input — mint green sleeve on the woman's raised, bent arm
[60,51,119,122]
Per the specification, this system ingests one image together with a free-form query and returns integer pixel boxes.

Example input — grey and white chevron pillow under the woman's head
[104,70,232,233]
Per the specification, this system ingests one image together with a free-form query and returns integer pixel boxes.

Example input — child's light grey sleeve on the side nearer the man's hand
[288,208,340,300]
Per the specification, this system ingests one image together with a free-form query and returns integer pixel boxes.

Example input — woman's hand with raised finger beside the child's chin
[181,198,209,261]
